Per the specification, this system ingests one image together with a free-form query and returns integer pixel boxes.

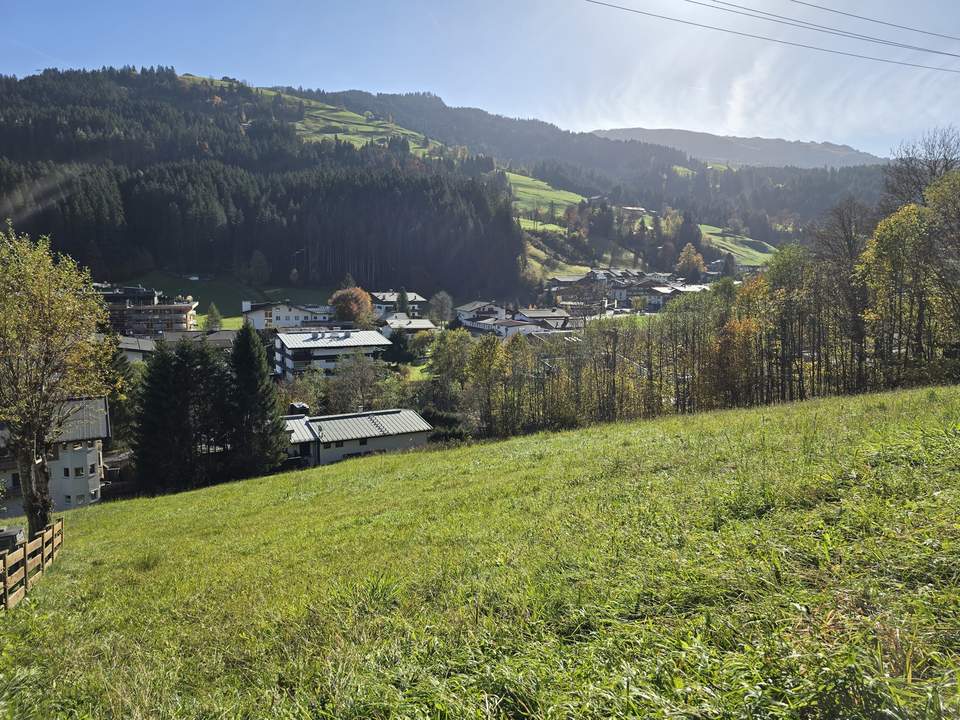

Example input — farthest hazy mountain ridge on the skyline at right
[594,128,885,168]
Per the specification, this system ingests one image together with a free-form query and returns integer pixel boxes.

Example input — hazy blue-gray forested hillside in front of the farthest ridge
[286,88,883,241]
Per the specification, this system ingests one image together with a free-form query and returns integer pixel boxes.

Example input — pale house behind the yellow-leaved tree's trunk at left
[0,398,110,517]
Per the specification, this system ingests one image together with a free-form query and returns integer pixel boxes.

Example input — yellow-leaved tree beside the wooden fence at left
[0,223,112,535]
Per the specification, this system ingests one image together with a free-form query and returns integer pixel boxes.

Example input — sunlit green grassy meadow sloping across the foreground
[0,388,960,718]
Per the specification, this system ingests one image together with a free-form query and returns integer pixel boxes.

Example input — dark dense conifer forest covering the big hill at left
[0,68,524,292]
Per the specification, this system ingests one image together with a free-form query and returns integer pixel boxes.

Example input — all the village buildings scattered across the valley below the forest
[0,268,719,517]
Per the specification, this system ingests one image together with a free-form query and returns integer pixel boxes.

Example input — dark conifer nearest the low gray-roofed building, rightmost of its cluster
[230,323,288,477]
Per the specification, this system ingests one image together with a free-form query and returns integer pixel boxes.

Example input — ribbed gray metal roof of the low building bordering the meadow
[284,409,433,443]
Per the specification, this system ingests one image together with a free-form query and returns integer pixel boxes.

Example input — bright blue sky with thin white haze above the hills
[0,0,960,155]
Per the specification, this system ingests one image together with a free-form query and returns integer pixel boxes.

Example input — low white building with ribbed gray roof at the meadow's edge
[284,410,433,466]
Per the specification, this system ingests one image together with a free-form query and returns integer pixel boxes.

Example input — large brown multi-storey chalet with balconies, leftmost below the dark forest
[94,283,199,336]
